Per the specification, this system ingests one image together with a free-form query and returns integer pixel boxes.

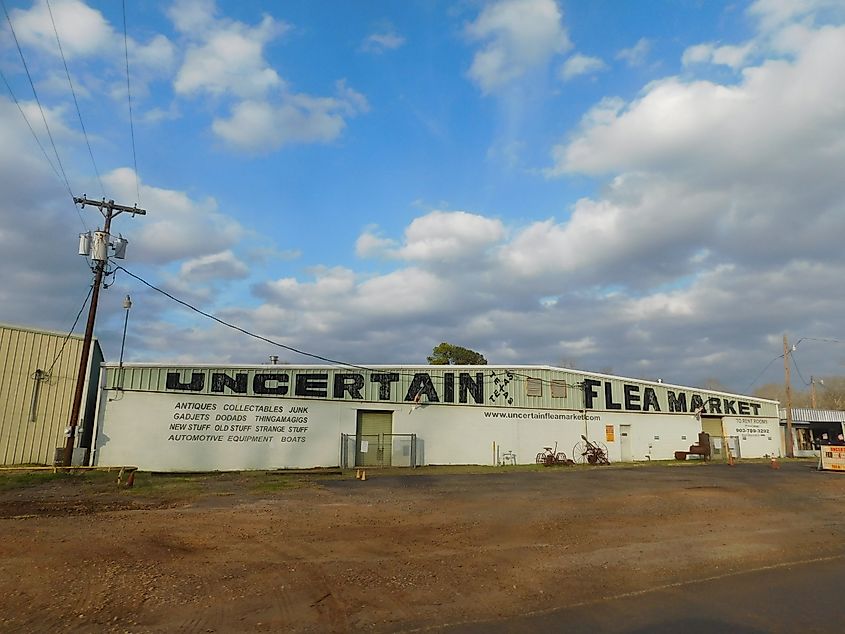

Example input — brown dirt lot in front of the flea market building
[0,461,845,632]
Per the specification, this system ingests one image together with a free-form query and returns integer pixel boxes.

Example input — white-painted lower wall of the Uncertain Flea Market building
[95,391,779,471]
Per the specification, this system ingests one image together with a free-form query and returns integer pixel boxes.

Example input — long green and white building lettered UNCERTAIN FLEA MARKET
[93,364,780,471]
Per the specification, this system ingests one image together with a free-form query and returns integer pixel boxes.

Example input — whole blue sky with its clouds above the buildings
[0,0,845,390]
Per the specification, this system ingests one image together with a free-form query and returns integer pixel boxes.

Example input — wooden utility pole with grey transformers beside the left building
[62,194,147,467]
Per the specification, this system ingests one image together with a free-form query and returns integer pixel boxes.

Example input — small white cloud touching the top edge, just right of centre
[466,0,572,93]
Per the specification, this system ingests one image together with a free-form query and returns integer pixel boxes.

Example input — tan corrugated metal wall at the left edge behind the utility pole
[0,325,98,465]
